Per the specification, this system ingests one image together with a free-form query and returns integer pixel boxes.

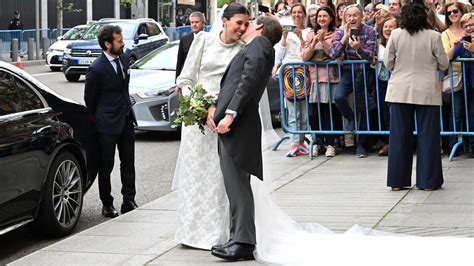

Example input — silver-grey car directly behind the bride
[129,41,280,131]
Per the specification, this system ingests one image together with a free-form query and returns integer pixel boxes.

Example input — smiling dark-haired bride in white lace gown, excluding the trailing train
[173,4,249,250]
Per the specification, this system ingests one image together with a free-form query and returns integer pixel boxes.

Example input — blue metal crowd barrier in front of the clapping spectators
[273,59,474,160]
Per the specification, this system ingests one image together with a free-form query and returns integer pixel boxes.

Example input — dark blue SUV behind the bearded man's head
[63,18,169,81]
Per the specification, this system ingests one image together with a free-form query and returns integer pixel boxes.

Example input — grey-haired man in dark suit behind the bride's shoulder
[176,11,206,78]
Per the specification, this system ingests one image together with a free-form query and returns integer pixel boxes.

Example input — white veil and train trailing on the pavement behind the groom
[251,100,474,266]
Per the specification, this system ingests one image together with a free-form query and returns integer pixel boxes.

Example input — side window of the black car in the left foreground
[0,71,22,116]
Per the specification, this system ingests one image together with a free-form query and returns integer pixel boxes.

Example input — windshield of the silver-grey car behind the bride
[133,43,179,70]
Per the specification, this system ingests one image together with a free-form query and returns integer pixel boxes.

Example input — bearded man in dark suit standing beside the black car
[84,26,137,218]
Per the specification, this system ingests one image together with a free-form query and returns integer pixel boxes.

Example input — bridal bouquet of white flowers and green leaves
[173,84,216,134]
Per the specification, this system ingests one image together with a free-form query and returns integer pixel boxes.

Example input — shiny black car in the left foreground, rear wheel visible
[0,62,97,236]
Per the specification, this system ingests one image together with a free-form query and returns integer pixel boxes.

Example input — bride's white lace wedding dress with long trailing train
[173,17,474,266]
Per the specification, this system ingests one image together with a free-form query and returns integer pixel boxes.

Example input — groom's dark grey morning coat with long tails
[214,36,275,179]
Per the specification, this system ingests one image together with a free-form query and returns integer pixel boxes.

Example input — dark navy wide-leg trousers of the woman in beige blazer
[387,103,444,189]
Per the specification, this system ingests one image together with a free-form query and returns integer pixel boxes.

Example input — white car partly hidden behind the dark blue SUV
[46,25,90,71]
